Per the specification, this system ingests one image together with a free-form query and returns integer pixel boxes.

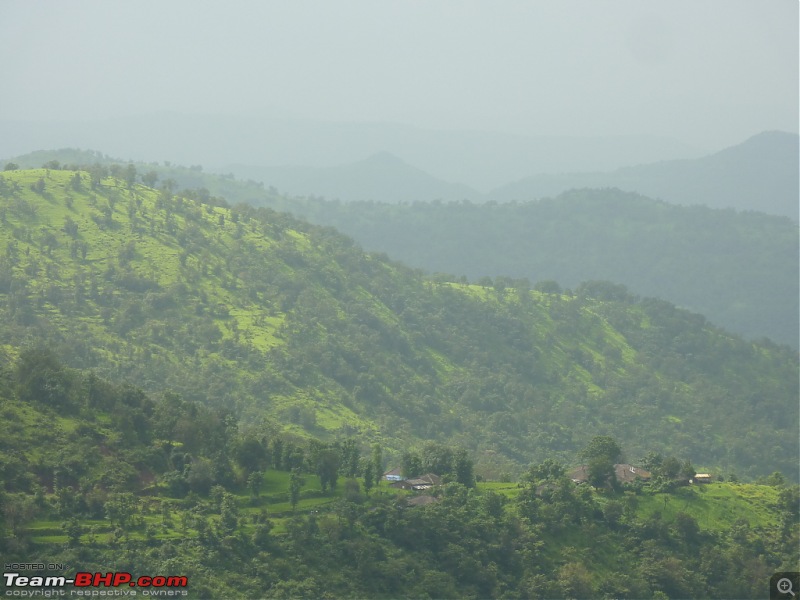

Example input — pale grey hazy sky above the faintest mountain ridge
[0,0,798,148]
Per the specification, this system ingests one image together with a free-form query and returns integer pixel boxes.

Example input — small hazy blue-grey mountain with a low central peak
[223,152,481,202]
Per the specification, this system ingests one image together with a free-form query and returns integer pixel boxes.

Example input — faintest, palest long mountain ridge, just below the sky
[0,113,701,192]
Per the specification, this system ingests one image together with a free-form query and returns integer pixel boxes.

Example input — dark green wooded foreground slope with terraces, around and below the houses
[0,358,798,598]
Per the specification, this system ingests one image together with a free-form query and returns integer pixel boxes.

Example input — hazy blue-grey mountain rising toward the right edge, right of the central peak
[489,131,800,221]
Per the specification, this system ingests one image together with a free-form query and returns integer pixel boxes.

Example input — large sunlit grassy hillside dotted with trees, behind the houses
[0,168,798,477]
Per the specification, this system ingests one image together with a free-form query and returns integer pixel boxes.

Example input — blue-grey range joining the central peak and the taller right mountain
[228,131,800,221]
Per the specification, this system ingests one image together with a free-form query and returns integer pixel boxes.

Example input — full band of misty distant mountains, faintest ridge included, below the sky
[0,119,800,221]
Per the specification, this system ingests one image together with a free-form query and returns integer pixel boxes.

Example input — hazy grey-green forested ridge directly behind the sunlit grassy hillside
[4,149,800,349]
